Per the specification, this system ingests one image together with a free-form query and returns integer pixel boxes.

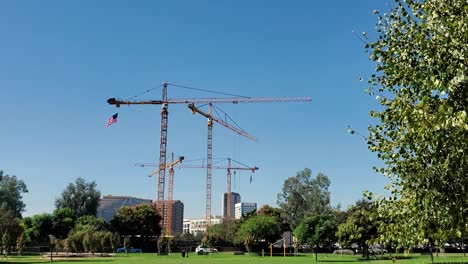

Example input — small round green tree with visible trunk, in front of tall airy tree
[294,215,337,262]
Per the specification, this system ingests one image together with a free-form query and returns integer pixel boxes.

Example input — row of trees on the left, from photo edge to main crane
[0,175,165,253]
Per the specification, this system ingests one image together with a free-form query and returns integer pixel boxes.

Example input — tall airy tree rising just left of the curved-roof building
[55,178,101,217]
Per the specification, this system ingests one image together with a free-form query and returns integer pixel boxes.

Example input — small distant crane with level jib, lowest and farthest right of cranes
[135,158,258,219]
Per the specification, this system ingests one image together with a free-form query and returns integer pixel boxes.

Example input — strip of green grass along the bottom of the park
[0,253,468,264]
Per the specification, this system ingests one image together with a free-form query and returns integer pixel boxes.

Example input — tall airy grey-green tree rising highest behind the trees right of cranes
[277,168,330,228]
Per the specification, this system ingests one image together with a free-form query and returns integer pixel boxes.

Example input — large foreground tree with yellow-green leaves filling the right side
[366,0,468,256]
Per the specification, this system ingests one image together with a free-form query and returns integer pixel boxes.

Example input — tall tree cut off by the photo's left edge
[0,170,28,217]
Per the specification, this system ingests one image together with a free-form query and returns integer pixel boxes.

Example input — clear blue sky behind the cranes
[0,0,388,218]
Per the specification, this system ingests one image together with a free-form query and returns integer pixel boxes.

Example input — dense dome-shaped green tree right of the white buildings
[235,215,280,252]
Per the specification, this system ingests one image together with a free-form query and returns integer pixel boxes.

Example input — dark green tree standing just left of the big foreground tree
[336,199,379,257]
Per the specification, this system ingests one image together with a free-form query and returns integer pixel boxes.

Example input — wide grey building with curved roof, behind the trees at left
[96,195,153,222]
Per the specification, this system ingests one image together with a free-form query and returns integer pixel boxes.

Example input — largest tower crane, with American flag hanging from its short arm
[107,83,312,226]
